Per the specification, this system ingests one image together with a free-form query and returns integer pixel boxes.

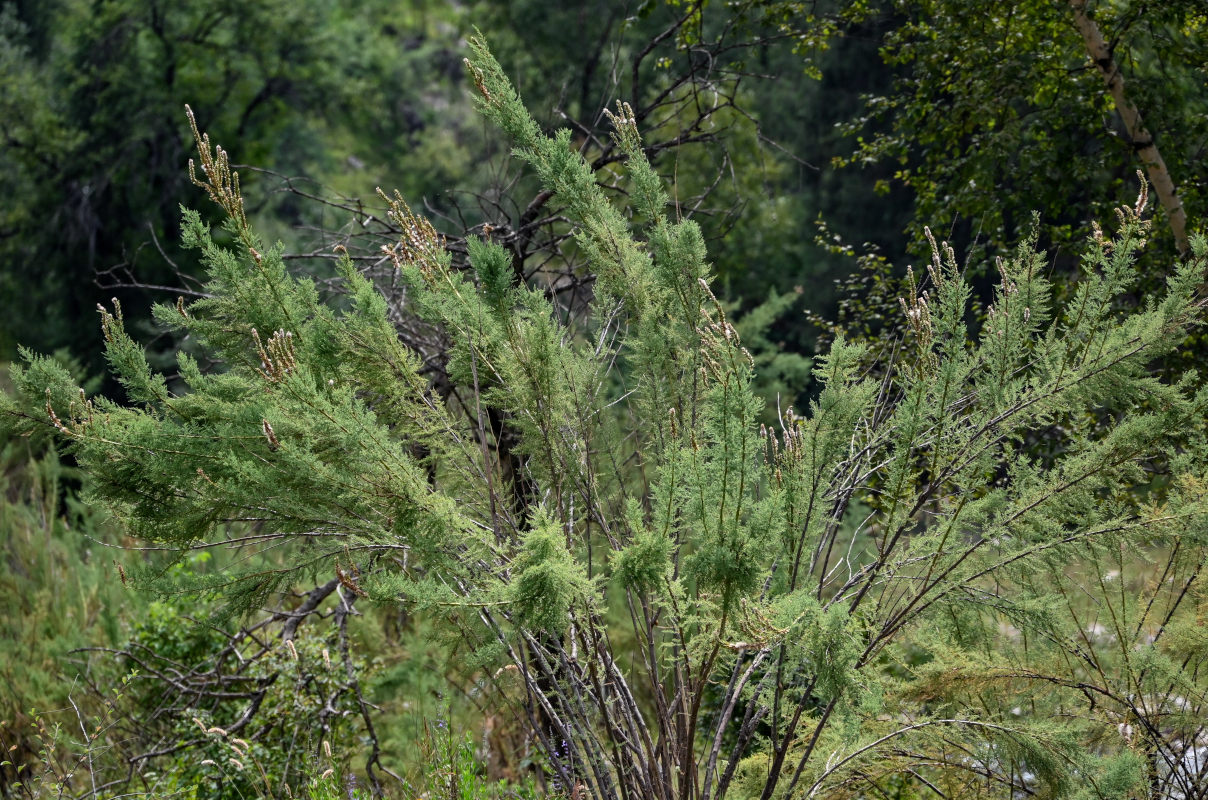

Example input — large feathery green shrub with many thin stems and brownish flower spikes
[4,39,1208,800]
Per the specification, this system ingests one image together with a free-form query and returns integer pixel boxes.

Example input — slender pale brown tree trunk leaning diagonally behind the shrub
[1069,0,1189,254]
